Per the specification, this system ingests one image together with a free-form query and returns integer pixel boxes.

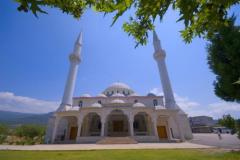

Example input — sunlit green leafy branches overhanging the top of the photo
[16,0,240,46]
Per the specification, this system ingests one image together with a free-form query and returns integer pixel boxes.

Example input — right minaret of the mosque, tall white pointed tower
[153,31,178,109]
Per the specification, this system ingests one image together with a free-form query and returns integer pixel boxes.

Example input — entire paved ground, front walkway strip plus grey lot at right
[0,133,240,151]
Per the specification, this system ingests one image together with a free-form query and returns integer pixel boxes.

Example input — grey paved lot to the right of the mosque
[189,133,240,149]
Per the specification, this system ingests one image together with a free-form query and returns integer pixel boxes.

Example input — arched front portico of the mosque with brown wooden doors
[49,104,186,143]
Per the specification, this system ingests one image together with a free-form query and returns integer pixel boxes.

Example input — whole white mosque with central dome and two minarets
[46,32,192,144]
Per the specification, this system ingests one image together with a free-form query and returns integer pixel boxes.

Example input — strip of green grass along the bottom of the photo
[0,149,240,160]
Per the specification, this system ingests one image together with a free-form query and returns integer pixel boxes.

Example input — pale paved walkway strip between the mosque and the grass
[0,142,214,150]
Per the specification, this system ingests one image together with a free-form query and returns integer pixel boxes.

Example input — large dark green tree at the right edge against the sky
[207,18,240,102]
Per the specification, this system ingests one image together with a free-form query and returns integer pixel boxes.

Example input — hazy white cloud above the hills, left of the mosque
[0,92,59,113]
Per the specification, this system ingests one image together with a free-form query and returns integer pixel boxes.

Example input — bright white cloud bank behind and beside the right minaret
[150,88,240,118]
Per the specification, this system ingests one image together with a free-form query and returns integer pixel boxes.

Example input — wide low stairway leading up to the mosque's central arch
[97,137,138,144]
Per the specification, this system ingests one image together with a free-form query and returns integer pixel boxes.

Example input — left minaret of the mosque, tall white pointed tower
[57,32,82,111]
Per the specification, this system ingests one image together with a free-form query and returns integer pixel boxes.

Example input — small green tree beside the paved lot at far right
[218,114,236,134]
